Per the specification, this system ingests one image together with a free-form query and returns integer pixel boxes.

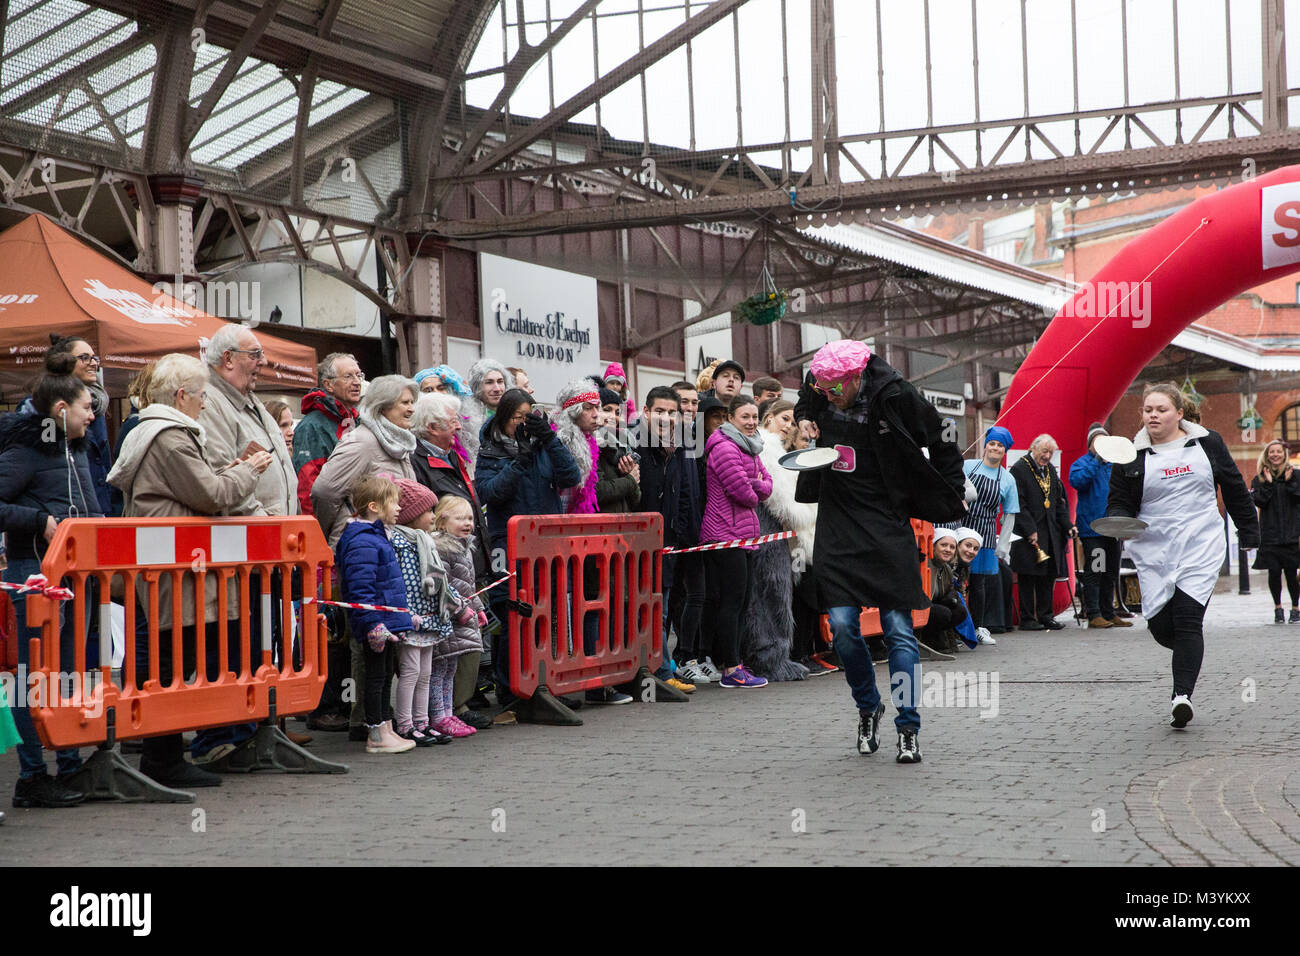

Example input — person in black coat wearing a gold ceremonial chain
[1010,434,1075,631]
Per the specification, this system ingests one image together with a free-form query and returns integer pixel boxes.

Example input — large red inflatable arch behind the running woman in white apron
[998,166,1300,470]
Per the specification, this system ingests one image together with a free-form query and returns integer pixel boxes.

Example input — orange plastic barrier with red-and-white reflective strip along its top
[27,518,334,748]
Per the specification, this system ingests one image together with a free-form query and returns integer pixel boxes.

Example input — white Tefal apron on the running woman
[1125,436,1227,620]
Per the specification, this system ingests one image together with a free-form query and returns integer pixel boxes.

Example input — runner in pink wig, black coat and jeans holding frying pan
[794,339,966,763]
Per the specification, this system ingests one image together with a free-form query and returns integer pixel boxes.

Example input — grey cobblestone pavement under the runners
[0,589,1300,865]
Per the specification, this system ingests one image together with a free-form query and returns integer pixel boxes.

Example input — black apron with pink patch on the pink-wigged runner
[813,415,930,610]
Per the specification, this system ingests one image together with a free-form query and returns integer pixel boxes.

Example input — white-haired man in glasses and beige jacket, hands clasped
[199,324,298,515]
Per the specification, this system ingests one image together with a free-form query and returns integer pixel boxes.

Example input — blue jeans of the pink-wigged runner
[827,607,920,731]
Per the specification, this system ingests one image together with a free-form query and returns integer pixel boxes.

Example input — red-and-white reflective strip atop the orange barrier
[95,524,282,567]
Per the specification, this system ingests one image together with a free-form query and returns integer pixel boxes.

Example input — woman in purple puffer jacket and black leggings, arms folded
[699,395,772,687]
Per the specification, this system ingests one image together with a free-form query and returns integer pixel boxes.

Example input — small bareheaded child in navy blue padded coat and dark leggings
[334,475,416,753]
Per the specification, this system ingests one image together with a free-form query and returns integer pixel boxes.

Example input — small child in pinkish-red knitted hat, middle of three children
[393,479,452,747]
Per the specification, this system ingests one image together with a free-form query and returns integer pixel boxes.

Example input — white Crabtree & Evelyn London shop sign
[478,252,605,403]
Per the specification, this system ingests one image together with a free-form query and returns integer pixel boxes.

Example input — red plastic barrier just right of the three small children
[506,514,663,697]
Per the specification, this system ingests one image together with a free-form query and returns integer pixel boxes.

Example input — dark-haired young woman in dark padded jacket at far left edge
[0,356,103,806]
